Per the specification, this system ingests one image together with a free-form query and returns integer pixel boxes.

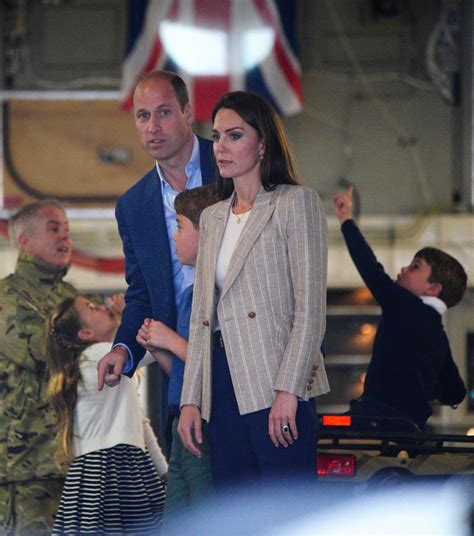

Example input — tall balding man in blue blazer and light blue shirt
[98,71,215,438]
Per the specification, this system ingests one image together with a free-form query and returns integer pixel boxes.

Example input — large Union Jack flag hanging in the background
[122,0,303,121]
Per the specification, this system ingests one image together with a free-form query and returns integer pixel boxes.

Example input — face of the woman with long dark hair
[212,108,265,180]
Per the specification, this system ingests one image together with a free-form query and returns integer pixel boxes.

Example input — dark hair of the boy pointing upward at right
[415,247,467,307]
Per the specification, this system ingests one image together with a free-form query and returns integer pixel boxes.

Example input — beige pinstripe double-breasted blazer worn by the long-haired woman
[181,185,329,421]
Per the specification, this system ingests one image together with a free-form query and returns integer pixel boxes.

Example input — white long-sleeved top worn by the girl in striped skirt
[72,342,168,476]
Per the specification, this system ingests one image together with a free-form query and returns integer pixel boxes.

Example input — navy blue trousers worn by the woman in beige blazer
[209,332,318,489]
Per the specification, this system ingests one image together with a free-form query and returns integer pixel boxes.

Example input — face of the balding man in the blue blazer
[133,79,192,162]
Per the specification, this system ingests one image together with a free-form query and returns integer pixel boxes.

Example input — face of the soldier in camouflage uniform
[19,205,72,266]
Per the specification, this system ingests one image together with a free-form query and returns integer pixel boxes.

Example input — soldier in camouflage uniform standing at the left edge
[0,200,77,535]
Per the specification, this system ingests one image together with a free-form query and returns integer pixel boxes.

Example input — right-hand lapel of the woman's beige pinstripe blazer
[219,188,275,299]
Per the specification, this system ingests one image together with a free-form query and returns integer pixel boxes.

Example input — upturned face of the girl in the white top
[74,296,118,342]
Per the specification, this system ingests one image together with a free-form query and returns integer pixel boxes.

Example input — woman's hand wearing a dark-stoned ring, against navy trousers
[268,391,298,447]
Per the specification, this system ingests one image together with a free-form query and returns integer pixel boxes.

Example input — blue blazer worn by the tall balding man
[114,138,215,375]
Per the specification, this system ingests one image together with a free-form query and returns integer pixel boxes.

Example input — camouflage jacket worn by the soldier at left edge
[0,253,78,483]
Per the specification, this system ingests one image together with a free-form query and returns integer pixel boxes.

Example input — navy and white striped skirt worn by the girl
[53,444,166,535]
